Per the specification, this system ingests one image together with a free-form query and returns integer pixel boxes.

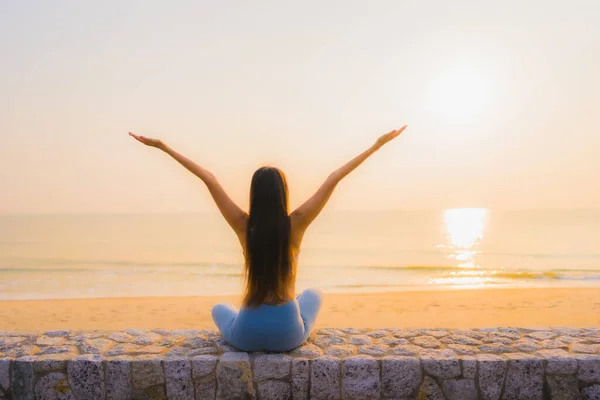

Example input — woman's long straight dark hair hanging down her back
[244,167,293,307]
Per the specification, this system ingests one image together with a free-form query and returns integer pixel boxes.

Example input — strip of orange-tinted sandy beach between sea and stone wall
[0,288,600,331]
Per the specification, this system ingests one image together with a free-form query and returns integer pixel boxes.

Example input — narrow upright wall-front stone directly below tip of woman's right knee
[310,356,341,399]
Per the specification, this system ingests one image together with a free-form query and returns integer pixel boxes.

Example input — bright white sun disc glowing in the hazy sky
[427,62,492,121]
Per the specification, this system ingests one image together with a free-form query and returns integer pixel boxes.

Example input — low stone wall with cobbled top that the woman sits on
[0,328,600,400]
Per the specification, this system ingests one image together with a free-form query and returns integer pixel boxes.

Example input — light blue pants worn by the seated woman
[212,289,322,351]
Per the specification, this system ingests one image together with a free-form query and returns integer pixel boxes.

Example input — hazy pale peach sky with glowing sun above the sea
[0,0,600,214]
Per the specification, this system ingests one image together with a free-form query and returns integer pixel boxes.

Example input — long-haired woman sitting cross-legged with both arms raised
[129,126,406,351]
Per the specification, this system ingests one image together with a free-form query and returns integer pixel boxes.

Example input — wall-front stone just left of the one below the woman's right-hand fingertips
[342,356,381,399]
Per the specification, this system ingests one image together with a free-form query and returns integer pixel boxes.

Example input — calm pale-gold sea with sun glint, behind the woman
[0,209,600,299]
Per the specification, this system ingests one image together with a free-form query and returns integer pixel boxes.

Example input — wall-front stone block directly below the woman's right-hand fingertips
[381,356,423,397]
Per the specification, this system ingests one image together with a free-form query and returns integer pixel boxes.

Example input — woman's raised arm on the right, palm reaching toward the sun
[292,125,406,236]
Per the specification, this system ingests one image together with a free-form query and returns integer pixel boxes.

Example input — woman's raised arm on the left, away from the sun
[129,132,247,244]
